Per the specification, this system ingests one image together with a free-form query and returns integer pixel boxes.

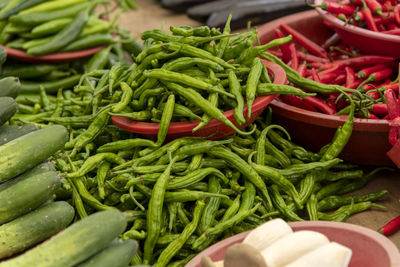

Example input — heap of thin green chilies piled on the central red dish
[72,14,313,136]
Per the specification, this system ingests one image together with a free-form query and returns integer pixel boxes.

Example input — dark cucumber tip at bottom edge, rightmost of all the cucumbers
[76,239,138,267]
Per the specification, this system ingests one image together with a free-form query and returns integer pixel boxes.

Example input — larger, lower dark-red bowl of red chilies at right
[259,11,400,165]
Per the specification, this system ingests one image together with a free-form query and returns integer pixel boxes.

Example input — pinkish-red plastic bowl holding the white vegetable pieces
[186,221,400,267]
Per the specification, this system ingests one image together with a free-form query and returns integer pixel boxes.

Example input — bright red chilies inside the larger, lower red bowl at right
[273,25,399,119]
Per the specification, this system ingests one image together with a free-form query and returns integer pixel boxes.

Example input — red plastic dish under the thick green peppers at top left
[2,45,106,63]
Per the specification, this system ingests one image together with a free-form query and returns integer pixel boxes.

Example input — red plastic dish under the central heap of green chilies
[111,62,287,140]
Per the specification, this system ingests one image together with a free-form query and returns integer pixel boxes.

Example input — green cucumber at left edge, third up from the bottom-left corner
[0,165,60,224]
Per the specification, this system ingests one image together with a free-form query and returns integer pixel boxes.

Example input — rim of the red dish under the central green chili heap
[111,61,287,134]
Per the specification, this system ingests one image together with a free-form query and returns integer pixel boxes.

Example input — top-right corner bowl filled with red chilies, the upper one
[313,0,400,57]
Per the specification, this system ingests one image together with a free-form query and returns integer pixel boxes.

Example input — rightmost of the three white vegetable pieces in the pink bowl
[286,242,352,267]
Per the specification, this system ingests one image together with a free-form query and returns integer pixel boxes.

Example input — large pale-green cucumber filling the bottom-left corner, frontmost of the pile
[0,210,126,267]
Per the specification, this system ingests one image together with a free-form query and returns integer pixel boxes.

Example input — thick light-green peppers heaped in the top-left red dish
[0,0,135,55]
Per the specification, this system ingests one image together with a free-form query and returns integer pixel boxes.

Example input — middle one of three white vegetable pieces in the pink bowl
[261,231,329,267]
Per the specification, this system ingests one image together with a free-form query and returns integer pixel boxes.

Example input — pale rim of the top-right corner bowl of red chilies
[314,0,400,44]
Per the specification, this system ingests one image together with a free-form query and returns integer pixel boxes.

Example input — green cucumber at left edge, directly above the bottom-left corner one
[0,201,75,259]
